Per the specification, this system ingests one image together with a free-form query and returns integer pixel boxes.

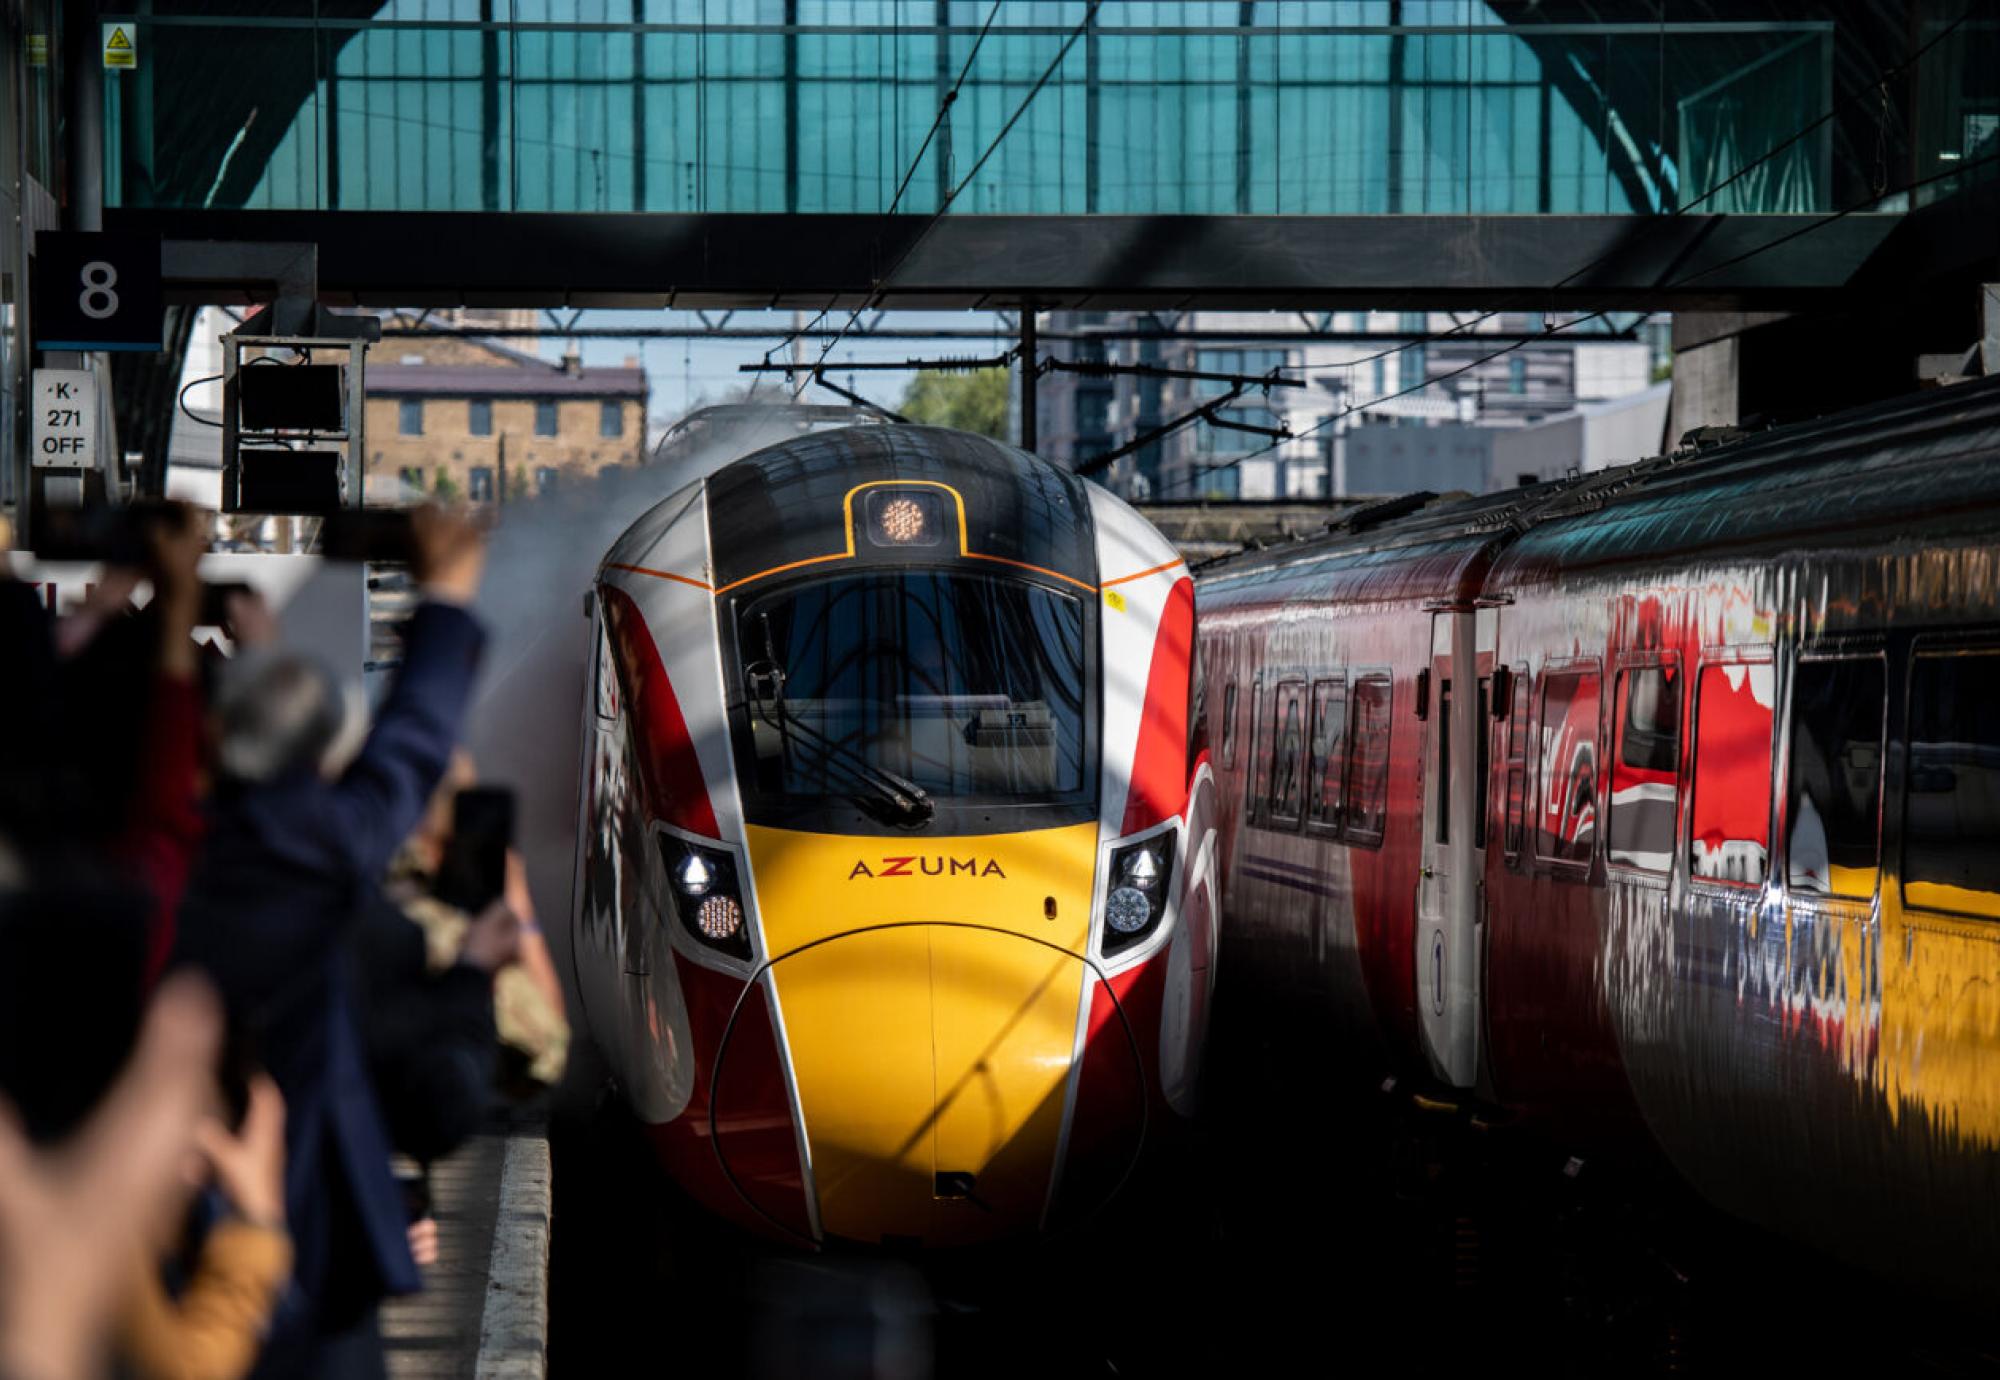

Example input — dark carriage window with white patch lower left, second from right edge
[1784,656,1884,896]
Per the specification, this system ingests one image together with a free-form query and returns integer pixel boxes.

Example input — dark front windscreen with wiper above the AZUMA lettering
[736,566,1094,824]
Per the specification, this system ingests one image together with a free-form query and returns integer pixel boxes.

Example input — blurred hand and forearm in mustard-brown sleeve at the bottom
[118,1074,292,1380]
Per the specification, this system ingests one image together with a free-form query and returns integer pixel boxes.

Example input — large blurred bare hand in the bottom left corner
[0,978,222,1380]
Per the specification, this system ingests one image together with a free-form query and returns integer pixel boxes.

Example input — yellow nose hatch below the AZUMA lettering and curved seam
[772,924,1086,1246]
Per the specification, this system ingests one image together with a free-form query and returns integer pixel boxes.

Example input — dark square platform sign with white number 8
[30,230,162,350]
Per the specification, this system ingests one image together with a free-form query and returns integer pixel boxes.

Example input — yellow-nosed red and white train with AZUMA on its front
[572,426,1216,1248]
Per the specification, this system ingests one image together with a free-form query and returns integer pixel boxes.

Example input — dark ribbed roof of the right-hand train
[1200,378,2000,598]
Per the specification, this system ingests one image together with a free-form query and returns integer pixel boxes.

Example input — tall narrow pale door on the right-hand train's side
[1416,606,1496,1088]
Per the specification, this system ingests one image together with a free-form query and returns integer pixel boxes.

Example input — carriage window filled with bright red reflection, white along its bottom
[1688,664,1776,886]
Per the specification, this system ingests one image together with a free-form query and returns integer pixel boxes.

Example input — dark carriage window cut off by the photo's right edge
[1902,648,2000,920]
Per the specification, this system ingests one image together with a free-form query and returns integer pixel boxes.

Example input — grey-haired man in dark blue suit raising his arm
[178,508,484,1380]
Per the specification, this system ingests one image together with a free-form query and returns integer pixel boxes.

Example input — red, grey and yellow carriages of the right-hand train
[1198,380,2000,1298]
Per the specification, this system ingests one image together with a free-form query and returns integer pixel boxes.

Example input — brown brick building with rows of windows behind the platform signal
[368,338,646,502]
